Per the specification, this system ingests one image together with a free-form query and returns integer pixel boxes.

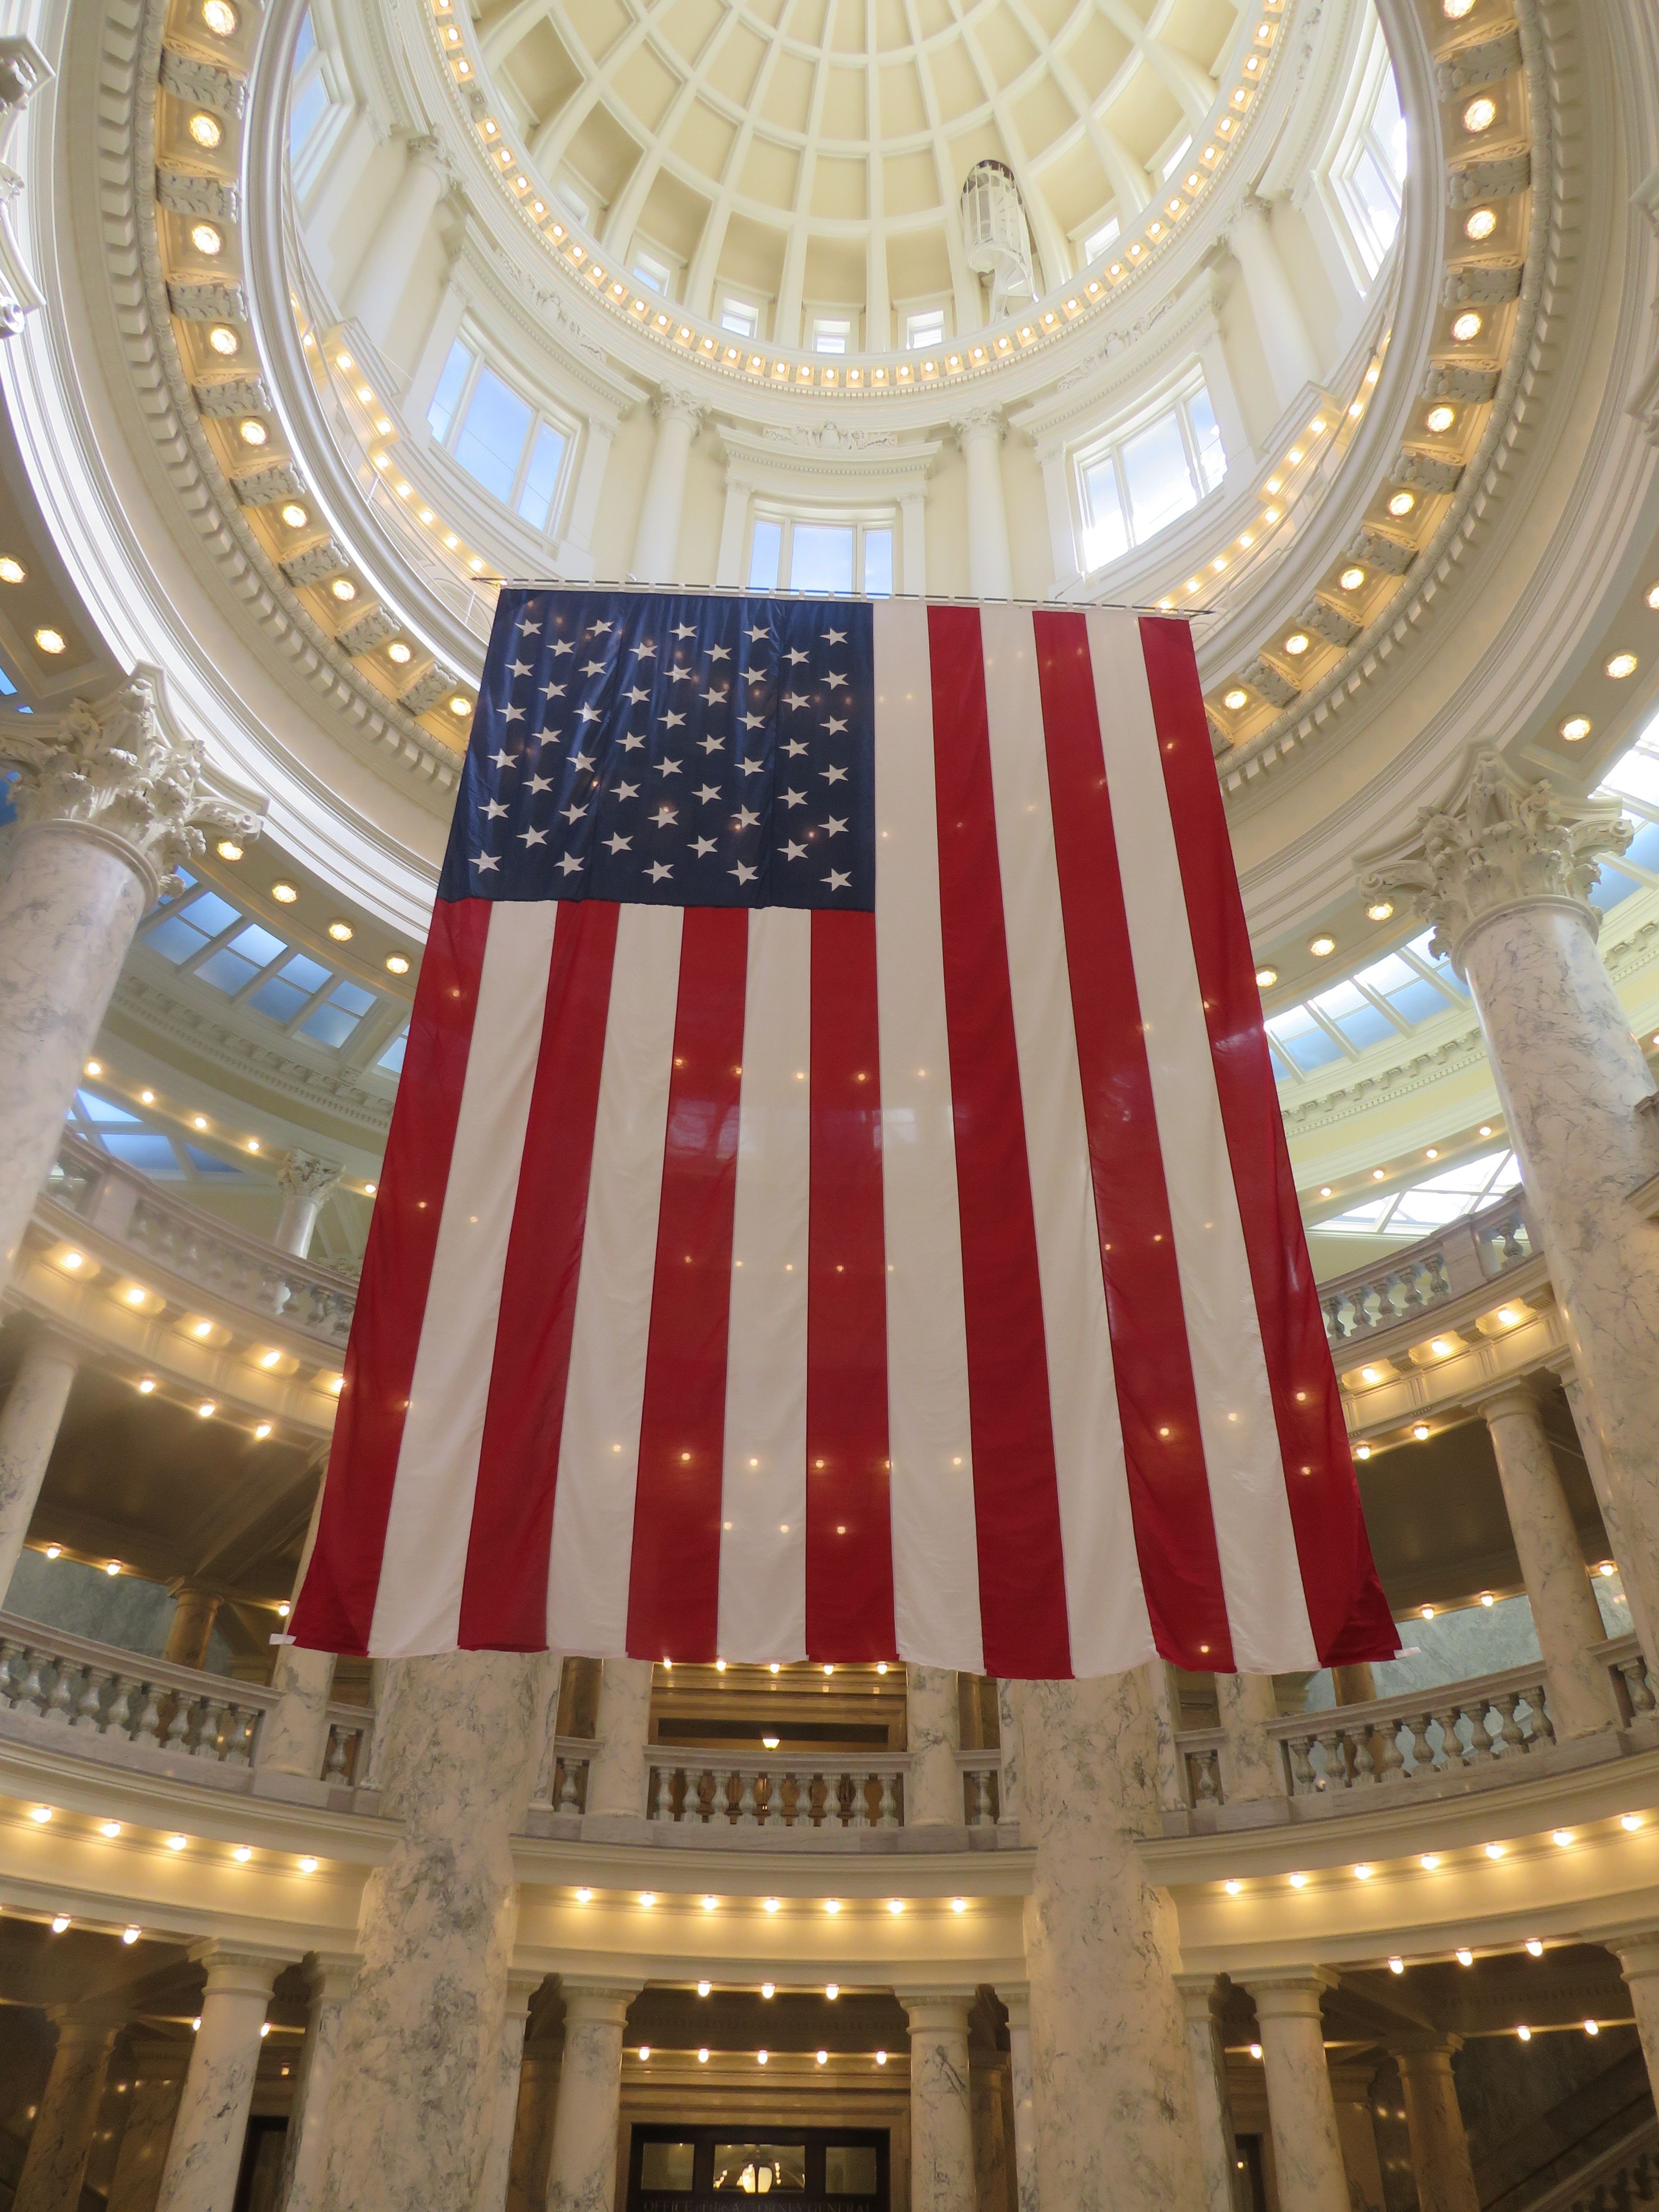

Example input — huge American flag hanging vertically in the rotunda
[294,591,1396,1677]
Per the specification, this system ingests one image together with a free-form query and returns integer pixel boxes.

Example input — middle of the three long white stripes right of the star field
[980,606,1153,1675]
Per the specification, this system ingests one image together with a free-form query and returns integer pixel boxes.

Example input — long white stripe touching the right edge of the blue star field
[874,600,984,1675]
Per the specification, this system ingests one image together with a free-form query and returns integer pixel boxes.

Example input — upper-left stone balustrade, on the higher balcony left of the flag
[38,1132,356,1349]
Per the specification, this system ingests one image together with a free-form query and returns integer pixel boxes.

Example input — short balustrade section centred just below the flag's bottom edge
[646,1750,909,1836]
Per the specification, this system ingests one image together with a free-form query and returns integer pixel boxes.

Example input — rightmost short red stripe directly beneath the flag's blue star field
[807,914,898,1661]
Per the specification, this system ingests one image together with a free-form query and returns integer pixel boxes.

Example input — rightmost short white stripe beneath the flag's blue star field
[719,907,812,1659]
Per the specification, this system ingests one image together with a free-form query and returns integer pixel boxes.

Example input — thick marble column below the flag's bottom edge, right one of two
[1015,1668,1203,2212]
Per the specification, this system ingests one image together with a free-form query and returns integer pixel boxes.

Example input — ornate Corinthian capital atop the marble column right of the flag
[1360,752,1633,973]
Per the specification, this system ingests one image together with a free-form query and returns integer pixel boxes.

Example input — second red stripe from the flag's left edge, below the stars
[460,900,620,1653]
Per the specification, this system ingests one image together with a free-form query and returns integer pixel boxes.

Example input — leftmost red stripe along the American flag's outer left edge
[292,898,491,1653]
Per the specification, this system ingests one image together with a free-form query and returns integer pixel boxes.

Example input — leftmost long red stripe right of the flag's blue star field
[927,606,1071,1677]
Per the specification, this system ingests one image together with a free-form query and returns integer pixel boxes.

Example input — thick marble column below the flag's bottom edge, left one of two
[321,1653,537,2212]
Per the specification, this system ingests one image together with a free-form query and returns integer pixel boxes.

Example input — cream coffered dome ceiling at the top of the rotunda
[473,0,1272,350]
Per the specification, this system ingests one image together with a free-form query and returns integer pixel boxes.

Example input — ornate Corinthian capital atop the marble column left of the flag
[0,679,259,898]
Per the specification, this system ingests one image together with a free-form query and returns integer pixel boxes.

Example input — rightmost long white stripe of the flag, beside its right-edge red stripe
[1088,613,1319,1675]
